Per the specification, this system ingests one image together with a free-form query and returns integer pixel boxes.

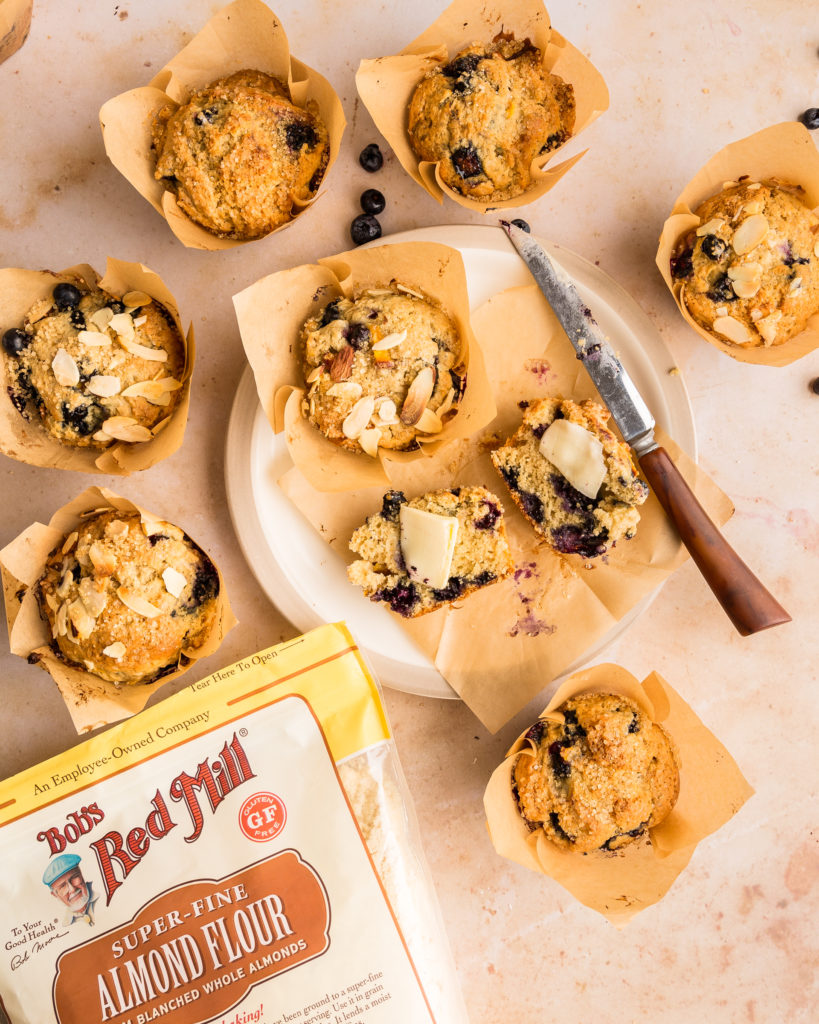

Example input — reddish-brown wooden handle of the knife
[639,447,790,637]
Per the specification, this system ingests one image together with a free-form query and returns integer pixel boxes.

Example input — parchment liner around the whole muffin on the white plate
[233,242,495,490]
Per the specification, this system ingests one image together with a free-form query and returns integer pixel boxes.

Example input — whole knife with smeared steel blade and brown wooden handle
[501,220,790,636]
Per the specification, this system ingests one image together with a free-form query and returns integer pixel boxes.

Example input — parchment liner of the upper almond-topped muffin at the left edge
[0,258,196,476]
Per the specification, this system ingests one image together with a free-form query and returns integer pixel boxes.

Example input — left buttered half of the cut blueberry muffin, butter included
[347,487,515,618]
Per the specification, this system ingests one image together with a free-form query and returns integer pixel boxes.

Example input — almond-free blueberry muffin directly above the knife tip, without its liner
[408,34,574,203]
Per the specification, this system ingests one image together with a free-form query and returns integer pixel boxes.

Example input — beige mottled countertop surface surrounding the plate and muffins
[0,0,819,1024]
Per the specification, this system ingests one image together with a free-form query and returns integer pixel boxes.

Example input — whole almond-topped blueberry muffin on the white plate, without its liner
[301,282,464,457]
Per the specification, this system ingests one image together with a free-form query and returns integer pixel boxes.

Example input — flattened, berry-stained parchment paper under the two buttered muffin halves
[279,276,733,731]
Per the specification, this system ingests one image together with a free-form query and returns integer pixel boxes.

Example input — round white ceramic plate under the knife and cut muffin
[225,225,696,697]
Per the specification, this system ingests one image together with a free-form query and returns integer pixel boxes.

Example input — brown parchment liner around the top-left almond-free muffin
[99,0,346,251]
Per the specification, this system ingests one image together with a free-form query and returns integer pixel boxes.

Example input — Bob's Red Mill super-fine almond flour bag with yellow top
[0,625,467,1024]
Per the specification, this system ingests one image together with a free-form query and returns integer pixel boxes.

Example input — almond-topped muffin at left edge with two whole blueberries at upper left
[2,275,185,449]
